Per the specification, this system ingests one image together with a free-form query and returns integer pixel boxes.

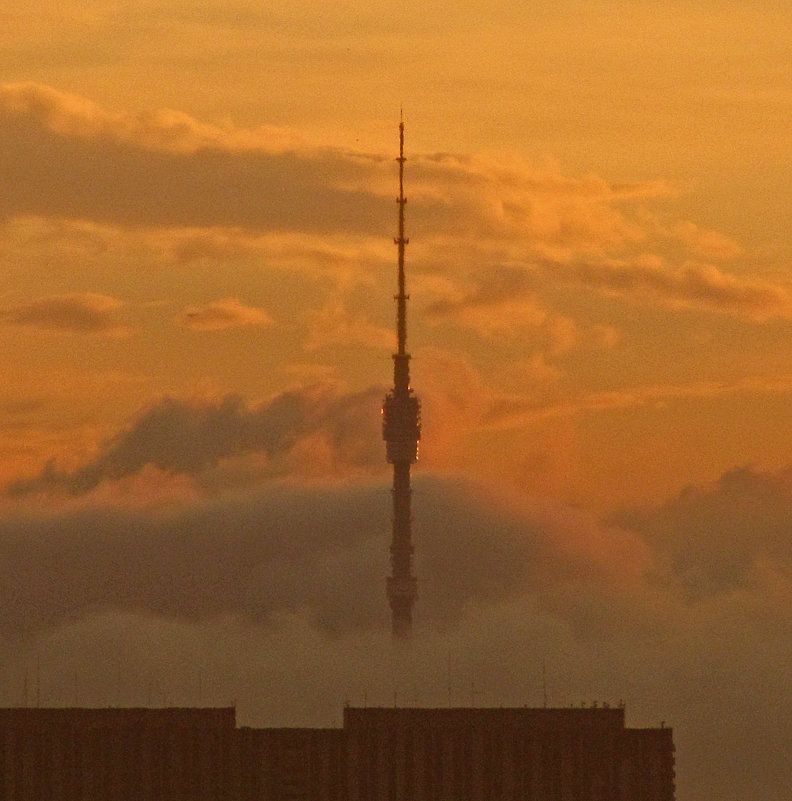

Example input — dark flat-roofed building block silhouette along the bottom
[0,707,674,801]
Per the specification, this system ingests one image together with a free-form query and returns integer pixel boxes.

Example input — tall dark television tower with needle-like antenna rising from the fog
[382,122,421,638]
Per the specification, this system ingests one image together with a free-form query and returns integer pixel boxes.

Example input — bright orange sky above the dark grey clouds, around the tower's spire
[0,2,792,507]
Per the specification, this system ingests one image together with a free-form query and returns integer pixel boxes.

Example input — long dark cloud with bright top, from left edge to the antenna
[0,86,390,232]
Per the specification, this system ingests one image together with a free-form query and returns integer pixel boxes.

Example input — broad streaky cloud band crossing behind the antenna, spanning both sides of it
[6,84,780,355]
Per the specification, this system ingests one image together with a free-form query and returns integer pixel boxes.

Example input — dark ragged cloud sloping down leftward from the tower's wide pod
[8,385,384,495]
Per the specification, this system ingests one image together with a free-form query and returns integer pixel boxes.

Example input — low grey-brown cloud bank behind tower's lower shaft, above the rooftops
[0,469,792,801]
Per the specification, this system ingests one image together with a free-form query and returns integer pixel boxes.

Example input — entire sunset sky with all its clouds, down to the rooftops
[0,0,792,801]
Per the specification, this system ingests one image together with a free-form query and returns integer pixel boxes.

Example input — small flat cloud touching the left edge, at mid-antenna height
[0,292,126,335]
